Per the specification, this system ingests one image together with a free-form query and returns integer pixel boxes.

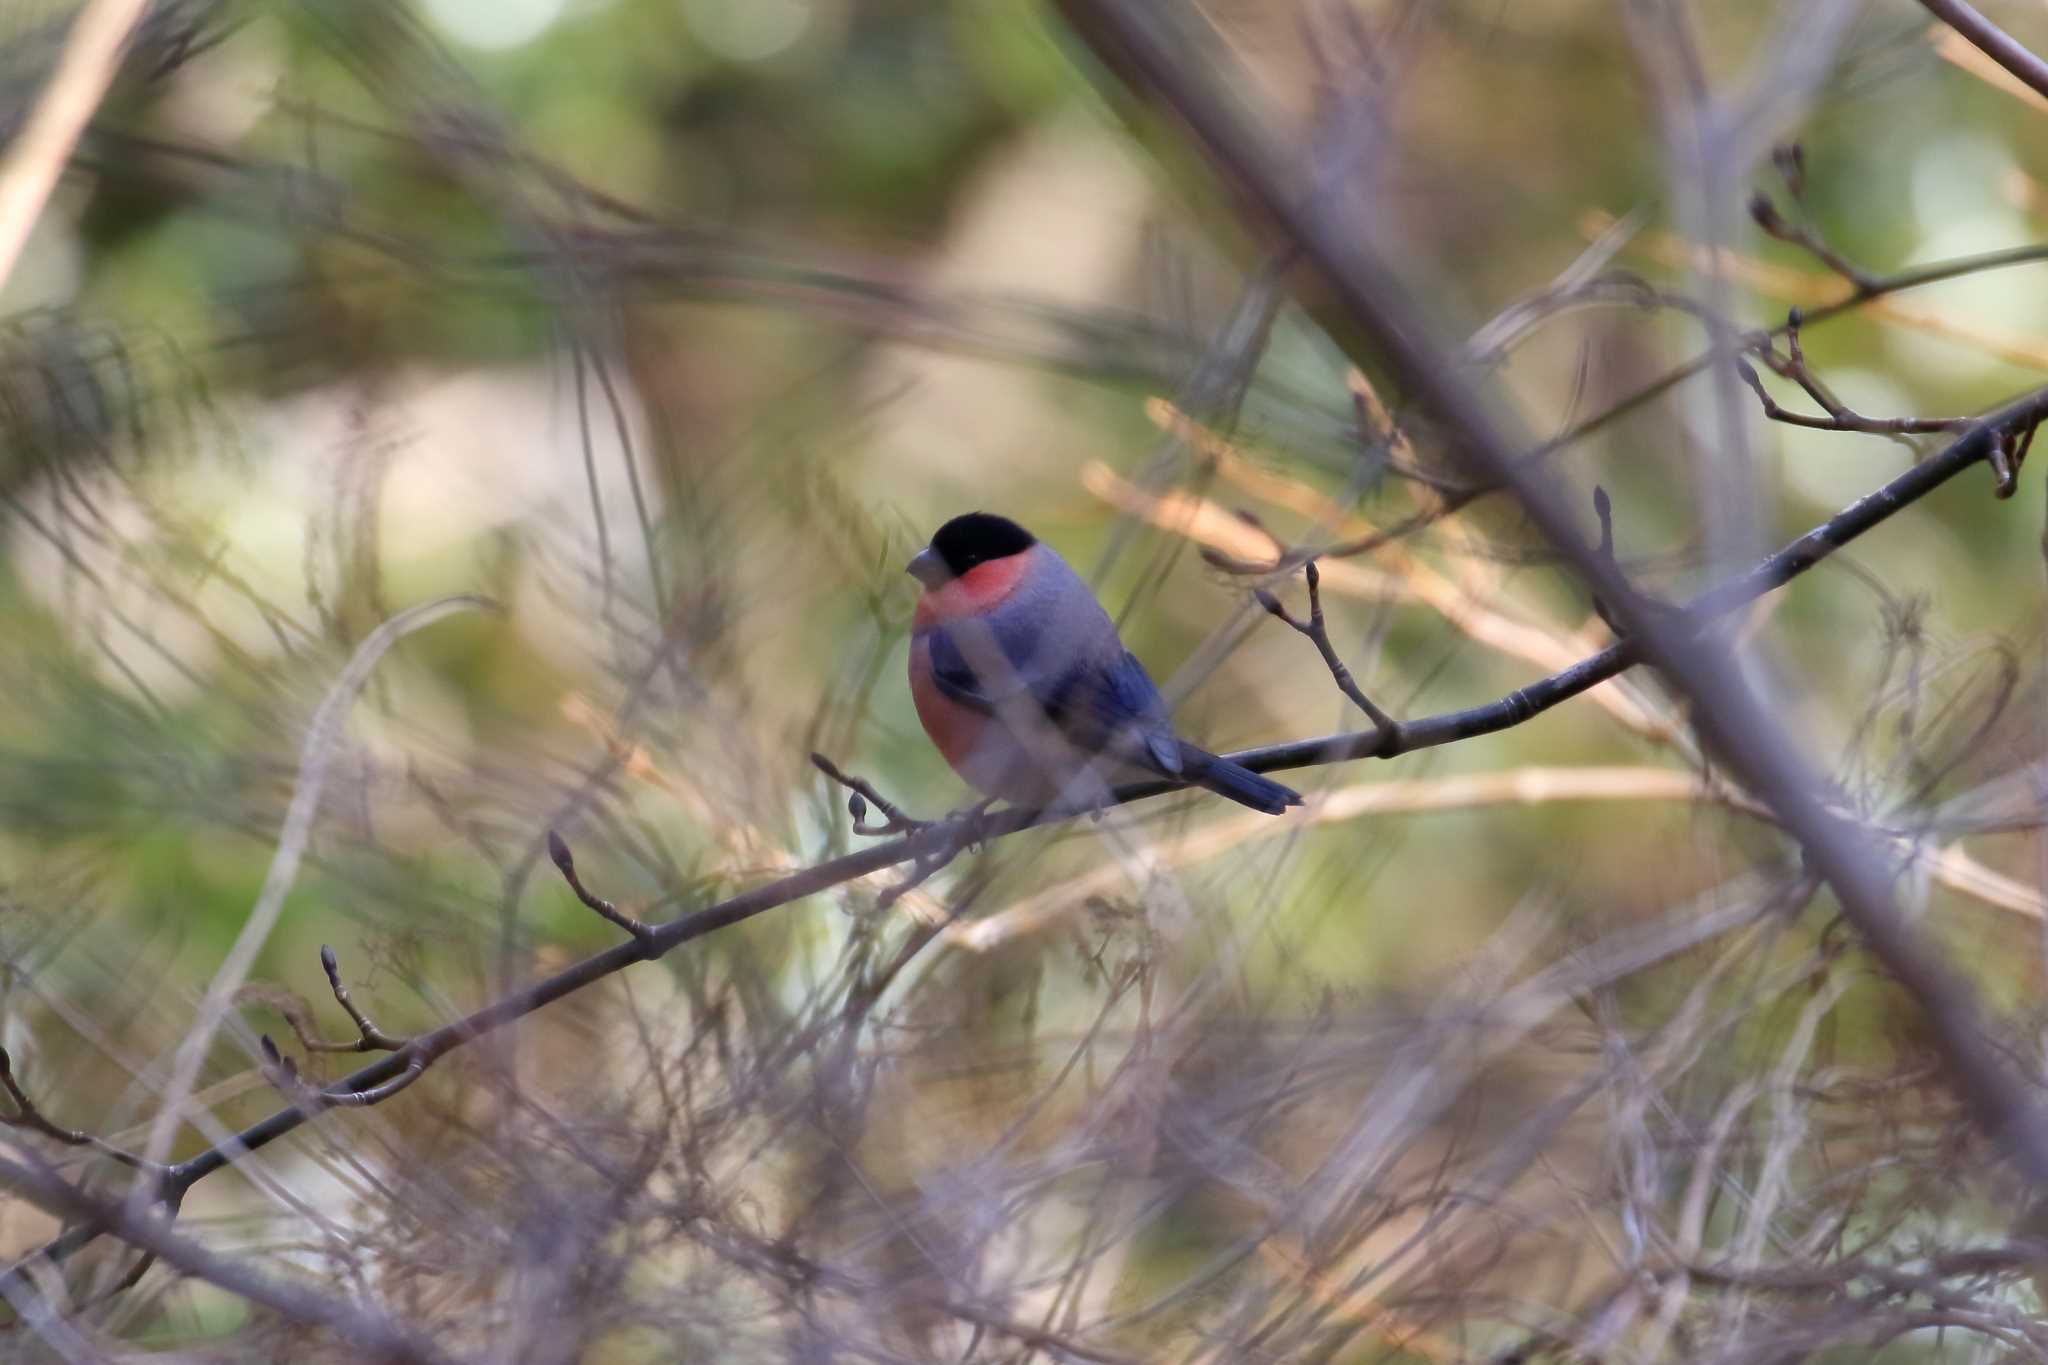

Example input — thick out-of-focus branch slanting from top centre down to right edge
[1061,0,2048,1183]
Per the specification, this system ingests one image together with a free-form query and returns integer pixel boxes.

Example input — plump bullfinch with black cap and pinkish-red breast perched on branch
[907,512,1300,814]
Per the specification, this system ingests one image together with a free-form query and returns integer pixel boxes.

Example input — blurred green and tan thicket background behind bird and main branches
[0,0,2048,1361]
